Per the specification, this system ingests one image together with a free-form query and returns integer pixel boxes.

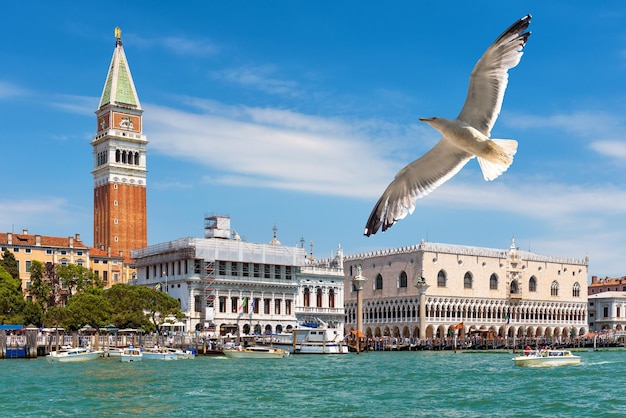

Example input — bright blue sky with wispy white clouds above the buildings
[0,0,626,277]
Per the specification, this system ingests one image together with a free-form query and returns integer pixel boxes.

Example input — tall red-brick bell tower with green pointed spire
[91,28,148,259]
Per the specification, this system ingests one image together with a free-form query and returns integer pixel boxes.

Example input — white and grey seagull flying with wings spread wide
[364,15,531,236]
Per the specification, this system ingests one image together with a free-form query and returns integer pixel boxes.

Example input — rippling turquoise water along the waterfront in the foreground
[0,351,626,417]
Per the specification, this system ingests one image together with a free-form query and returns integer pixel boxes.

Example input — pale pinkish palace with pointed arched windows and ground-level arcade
[344,241,588,339]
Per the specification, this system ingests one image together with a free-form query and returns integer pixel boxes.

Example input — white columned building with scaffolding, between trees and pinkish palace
[132,216,345,335]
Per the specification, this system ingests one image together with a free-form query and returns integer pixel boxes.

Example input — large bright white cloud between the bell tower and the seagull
[145,102,415,197]
